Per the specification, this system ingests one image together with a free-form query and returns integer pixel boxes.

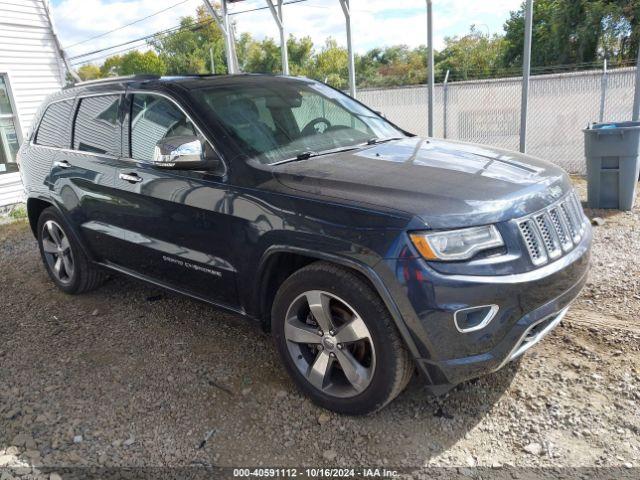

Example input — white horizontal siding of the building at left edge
[0,0,64,206]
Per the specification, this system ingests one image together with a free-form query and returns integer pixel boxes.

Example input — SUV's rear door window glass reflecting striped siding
[73,95,121,156]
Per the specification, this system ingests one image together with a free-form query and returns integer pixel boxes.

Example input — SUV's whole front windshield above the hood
[191,79,405,164]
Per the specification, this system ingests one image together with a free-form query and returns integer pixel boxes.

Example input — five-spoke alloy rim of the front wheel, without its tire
[284,290,376,398]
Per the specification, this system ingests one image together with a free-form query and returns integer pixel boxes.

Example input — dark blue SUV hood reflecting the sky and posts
[273,137,571,228]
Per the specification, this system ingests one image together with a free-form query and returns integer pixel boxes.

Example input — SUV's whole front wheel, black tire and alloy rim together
[271,262,414,415]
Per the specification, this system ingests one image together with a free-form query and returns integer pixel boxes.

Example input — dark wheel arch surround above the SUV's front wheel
[254,245,419,358]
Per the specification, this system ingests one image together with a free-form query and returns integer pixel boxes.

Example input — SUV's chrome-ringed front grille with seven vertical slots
[517,192,586,266]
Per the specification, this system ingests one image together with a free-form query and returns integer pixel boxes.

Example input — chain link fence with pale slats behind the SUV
[357,68,635,174]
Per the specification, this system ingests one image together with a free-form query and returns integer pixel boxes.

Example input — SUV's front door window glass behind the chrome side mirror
[131,94,197,162]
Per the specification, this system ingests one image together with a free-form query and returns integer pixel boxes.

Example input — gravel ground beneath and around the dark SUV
[0,180,640,480]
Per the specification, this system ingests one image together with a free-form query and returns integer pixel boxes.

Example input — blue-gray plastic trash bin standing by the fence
[583,122,640,210]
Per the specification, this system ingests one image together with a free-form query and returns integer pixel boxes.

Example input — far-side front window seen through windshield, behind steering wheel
[291,92,369,133]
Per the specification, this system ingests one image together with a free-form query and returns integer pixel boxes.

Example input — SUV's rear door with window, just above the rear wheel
[51,93,122,261]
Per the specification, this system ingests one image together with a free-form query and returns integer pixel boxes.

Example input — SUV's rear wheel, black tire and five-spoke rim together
[37,207,105,294]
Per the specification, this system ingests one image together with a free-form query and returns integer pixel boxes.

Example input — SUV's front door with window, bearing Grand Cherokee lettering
[107,92,237,307]
